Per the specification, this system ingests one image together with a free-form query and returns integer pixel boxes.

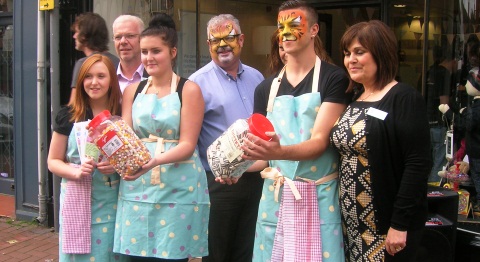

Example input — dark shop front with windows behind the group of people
[5,0,480,258]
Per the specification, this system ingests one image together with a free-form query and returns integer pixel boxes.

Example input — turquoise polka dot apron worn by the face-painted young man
[253,57,344,261]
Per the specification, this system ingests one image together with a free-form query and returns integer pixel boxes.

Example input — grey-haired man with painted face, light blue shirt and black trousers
[189,14,264,262]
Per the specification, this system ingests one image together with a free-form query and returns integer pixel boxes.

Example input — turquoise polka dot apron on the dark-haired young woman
[115,74,210,259]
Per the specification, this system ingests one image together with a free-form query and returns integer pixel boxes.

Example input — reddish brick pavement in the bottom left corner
[0,216,58,262]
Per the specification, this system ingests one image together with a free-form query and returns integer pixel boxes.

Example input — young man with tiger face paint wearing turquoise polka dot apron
[241,0,350,261]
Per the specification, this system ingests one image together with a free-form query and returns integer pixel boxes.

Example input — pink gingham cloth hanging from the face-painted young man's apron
[271,181,322,262]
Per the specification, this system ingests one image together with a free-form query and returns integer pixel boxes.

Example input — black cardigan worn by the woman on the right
[365,83,432,234]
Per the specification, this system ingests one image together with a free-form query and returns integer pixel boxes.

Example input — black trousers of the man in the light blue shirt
[203,172,263,262]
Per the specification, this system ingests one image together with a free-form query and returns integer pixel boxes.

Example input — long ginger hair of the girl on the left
[70,54,122,122]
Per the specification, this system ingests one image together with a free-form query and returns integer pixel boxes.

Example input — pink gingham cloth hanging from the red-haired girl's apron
[62,164,92,254]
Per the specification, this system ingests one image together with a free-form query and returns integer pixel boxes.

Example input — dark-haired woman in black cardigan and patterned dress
[330,20,431,261]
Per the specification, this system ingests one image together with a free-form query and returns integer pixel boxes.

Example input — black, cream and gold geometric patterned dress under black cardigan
[330,101,386,261]
